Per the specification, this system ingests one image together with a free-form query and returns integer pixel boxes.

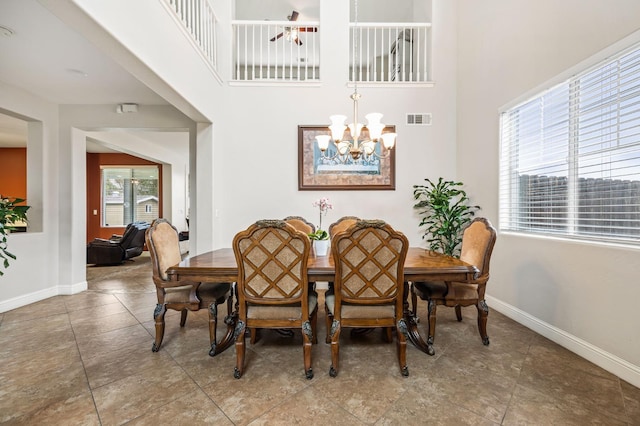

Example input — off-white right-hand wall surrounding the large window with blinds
[457,0,640,386]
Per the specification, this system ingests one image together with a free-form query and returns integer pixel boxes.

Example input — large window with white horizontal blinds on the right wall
[500,45,640,245]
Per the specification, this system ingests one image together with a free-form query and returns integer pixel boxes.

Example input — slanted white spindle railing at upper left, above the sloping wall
[163,0,218,71]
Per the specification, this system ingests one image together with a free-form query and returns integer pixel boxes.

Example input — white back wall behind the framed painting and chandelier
[214,0,456,247]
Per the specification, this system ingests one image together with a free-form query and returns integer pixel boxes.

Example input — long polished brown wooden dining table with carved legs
[167,247,478,356]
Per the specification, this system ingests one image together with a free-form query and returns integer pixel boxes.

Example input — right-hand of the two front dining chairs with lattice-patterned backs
[325,220,409,377]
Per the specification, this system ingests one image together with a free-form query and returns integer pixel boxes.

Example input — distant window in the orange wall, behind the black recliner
[101,166,159,227]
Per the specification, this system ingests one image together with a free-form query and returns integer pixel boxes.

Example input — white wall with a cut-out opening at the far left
[0,82,60,312]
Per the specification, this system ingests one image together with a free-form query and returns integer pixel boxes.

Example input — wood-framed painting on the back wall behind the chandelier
[298,126,396,191]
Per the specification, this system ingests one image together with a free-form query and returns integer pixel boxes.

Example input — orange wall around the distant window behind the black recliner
[87,153,162,242]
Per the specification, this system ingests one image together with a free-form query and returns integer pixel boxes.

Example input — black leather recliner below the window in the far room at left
[87,222,149,265]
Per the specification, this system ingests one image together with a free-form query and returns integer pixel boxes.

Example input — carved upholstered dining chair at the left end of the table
[145,218,233,356]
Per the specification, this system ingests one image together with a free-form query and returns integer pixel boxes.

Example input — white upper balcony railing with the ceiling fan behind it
[231,21,320,82]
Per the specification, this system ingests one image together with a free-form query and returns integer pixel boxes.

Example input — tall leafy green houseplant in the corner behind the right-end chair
[413,178,480,256]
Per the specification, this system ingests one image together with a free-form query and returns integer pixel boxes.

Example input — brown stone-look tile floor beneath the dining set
[0,251,640,425]
